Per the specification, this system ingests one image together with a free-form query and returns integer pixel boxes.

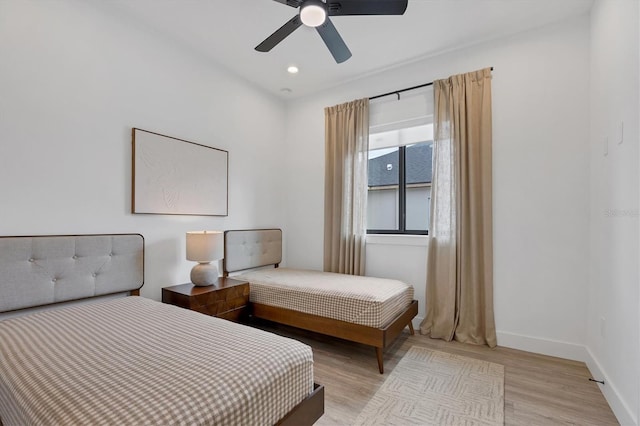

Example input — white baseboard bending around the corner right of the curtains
[496,331,638,426]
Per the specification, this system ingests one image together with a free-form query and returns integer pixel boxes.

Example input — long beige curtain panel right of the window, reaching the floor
[420,68,496,347]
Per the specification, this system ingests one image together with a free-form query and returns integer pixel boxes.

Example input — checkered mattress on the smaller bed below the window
[238,268,413,328]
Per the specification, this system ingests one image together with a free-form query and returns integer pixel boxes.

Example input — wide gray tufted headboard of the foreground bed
[0,234,144,312]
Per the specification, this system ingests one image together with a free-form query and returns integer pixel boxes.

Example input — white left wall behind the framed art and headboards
[0,0,285,299]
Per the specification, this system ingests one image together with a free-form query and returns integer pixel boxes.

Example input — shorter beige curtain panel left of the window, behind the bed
[324,99,369,275]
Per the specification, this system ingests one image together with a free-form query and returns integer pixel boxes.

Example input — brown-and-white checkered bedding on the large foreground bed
[0,297,313,426]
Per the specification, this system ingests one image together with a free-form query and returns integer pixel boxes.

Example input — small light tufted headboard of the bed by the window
[222,229,282,276]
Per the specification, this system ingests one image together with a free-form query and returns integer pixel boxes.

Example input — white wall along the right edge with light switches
[587,0,640,424]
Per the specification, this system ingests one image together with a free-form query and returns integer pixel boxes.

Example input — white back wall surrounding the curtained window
[285,16,589,350]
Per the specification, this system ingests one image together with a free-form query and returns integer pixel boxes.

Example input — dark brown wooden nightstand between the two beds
[162,277,249,322]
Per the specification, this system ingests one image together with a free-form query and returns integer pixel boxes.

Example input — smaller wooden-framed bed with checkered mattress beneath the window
[223,229,418,374]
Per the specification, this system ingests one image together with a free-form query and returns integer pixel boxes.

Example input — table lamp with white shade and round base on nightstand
[187,231,224,286]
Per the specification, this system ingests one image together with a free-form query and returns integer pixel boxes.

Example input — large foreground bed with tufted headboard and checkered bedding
[0,235,324,426]
